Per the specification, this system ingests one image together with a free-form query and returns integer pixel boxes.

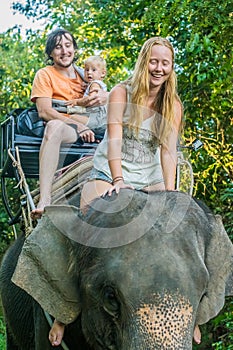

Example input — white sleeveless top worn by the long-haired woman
[94,86,164,190]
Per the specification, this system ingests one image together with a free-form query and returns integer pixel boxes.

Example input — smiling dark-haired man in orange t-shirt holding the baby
[31,29,108,219]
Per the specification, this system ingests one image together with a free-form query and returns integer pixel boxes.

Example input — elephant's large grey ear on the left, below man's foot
[12,205,81,324]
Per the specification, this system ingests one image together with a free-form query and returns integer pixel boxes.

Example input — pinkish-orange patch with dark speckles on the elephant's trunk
[136,293,193,349]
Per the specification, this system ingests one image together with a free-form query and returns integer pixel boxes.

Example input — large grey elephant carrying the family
[0,189,233,350]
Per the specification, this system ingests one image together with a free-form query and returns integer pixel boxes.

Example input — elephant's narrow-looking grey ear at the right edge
[196,215,233,324]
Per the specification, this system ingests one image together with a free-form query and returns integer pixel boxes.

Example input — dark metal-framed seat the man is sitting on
[0,109,98,225]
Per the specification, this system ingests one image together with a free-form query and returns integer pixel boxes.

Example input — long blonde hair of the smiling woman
[126,37,180,143]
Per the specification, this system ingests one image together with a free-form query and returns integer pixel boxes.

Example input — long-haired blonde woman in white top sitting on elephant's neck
[81,37,182,207]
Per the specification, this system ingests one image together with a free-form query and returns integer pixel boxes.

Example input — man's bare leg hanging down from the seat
[31,120,77,219]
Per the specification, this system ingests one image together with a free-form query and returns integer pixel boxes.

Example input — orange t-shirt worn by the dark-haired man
[31,66,83,102]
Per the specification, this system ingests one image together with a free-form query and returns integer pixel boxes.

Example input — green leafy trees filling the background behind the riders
[0,0,233,350]
